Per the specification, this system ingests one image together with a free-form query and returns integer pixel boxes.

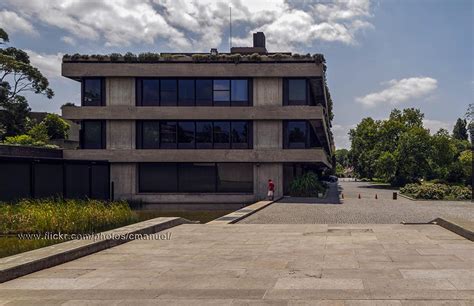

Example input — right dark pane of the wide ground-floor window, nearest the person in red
[217,163,253,193]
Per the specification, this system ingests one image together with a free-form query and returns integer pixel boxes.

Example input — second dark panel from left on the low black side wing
[34,163,63,198]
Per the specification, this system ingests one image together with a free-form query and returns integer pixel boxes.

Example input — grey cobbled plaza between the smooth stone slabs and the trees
[240,182,474,224]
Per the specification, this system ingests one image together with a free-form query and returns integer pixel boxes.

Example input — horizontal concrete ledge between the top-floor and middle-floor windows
[62,105,325,120]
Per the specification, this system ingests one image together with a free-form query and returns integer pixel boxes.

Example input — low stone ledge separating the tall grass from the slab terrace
[0,218,192,283]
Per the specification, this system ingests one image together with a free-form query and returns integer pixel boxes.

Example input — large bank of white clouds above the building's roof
[2,0,372,51]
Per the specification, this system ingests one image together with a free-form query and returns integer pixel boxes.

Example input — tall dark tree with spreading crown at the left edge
[0,28,54,137]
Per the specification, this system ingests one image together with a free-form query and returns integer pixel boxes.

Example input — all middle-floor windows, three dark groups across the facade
[81,120,322,149]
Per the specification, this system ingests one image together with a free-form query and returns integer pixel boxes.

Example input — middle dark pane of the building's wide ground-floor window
[178,163,216,192]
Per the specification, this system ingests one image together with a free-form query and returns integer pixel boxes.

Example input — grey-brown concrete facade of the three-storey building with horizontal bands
[62,34,333,203]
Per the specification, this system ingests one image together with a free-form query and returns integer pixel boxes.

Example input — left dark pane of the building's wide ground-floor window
[138,163,178,192]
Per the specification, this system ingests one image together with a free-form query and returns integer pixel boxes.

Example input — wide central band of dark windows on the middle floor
[137,120,252,149]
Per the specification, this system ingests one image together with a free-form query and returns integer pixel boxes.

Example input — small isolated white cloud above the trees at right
[356,77,438,107]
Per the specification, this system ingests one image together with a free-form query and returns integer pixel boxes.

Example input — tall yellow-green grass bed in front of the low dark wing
[0,198,136,234]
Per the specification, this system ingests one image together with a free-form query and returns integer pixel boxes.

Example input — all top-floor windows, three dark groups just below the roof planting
[82,78,324,106]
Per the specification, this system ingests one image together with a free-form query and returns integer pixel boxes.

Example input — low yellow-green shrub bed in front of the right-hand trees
[400,183,472,200]
